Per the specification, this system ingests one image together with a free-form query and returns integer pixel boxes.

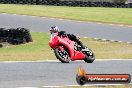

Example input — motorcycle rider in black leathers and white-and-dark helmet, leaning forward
[50,26,85,51]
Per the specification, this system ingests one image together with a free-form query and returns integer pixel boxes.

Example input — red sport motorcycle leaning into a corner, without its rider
[49,33,95,63]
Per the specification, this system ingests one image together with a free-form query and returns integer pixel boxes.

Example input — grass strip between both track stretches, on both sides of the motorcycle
[0,32,132,61]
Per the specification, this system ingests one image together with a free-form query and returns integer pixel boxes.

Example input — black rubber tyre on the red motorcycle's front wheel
[54,48,70,63]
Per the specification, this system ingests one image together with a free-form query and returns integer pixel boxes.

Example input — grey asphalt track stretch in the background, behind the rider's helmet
[0,14,132,42]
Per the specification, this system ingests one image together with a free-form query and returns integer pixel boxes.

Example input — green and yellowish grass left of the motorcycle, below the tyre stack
[0,33,55,61]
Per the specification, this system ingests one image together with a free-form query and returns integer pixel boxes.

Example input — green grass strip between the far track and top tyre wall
[0,4,132,24]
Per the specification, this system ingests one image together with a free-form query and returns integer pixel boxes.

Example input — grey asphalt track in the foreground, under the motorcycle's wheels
[0,60,132,88]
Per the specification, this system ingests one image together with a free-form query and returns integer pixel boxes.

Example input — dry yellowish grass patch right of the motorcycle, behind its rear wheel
[81,38,132,59]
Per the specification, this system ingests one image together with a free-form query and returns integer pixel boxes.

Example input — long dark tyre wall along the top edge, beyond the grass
[0,0,132,8]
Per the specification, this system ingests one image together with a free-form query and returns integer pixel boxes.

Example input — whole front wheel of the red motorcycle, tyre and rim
[54,48,70,63]
